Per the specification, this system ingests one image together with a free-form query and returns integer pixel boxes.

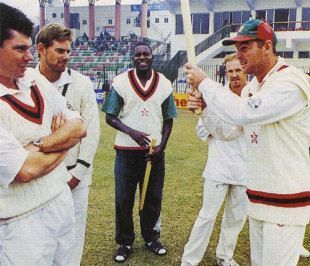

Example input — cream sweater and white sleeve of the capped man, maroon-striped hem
[199,58,310,225]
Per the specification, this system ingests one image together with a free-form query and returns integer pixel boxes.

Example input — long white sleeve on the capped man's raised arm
[199,78,307,126]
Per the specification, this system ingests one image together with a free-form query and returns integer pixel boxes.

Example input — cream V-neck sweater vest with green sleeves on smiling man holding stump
[102,70,176,150]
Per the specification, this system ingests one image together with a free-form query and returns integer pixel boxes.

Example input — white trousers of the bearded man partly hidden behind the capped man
[182,179,247,265]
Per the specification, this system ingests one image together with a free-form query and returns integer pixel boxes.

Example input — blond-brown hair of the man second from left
[36,23,72,47]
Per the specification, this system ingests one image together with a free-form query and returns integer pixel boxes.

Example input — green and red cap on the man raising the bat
[222,19,278,47]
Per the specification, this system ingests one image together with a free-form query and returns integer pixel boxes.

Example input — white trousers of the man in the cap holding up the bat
[249,217,306,266]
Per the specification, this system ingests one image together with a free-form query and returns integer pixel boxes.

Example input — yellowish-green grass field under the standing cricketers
[82,110,310,266]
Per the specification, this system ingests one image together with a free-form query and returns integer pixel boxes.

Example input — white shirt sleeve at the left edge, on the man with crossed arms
[0,125,28,188]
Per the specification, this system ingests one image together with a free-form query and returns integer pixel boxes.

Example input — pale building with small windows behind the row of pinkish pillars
[46,1,174,41]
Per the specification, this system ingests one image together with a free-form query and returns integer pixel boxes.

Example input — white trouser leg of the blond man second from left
[71,186,89,266]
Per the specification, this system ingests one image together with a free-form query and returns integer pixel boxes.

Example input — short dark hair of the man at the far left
[0,3,33,47]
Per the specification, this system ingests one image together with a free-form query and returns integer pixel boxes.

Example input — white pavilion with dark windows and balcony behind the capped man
[166,0,310,68]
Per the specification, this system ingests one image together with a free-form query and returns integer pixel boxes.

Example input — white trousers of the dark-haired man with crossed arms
[0,186,75,266]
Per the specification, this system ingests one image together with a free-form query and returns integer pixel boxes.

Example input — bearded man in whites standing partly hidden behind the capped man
[181,54,247,266]
